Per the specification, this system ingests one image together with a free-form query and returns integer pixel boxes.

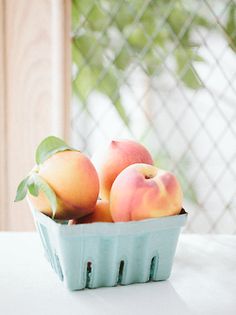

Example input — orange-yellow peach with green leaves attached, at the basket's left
[29,151,99,219]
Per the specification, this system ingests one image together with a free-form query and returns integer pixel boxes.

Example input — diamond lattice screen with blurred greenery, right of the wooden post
[71,0,236,233]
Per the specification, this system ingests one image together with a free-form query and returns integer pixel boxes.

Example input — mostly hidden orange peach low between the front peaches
[68,200,113,225]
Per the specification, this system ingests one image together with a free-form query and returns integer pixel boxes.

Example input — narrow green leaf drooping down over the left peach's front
[34,174,57,218]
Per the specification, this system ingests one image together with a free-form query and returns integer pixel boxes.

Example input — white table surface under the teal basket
[0,232,236,315]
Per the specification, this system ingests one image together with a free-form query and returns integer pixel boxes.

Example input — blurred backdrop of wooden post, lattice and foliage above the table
[0,0,236,234]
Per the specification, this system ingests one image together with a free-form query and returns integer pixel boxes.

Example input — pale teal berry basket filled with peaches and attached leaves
[15,136,187,290]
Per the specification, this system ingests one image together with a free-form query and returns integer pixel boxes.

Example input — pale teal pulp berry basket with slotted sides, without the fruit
[30,205,187,290]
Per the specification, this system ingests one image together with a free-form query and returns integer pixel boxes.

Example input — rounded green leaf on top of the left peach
[35,136,75,164]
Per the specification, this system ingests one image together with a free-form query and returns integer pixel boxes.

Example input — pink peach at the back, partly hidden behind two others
[94,140,153,200]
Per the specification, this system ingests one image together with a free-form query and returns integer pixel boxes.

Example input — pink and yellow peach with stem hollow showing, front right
[110,164,183,222]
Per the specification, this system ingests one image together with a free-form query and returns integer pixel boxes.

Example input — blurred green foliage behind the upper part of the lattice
[72,0,211,124]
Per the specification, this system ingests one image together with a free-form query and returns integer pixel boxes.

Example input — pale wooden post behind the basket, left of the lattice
[0,0,71,230]
